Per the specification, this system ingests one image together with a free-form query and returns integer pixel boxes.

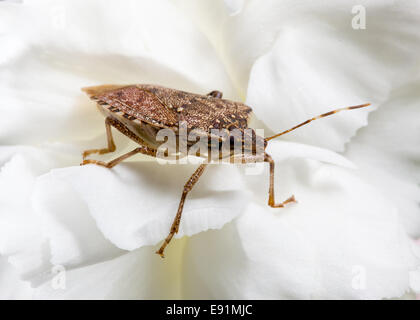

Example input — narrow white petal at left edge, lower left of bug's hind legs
[0,150,54,278]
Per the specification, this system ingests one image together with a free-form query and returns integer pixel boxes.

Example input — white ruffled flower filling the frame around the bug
[0,0,420,299]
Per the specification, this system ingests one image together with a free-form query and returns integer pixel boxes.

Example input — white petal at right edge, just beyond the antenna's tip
[346,81,420,237]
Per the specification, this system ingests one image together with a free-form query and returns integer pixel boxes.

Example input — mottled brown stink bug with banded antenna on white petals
[82,84,369,257]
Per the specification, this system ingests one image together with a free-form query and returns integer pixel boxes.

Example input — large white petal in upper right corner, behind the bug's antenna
[225,1,420,151]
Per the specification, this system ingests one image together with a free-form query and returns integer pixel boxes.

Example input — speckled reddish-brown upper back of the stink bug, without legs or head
[82,84,252,132]
